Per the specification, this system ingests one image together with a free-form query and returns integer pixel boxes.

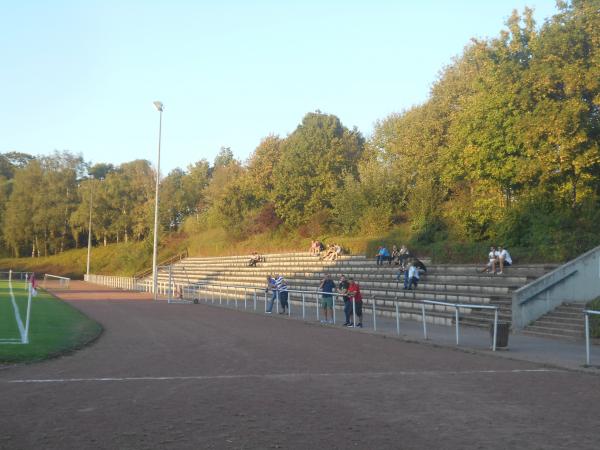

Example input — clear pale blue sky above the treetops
[0,0,556,174]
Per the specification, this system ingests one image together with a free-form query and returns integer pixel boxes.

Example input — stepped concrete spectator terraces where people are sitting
[143,253,555,327]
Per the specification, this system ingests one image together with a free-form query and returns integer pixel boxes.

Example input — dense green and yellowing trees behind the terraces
[0,0,600,260]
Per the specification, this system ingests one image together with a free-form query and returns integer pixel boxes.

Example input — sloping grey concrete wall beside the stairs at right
[512,247,600,330]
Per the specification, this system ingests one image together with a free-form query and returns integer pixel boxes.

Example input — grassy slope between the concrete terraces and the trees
[0,220,572,279]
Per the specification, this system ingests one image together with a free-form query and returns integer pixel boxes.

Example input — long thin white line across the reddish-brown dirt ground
[0,369,564,383]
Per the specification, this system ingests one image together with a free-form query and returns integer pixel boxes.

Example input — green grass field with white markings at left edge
[0,280,102,363]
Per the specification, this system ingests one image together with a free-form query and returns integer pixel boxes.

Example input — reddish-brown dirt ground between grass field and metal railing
[0,283,600,450]
